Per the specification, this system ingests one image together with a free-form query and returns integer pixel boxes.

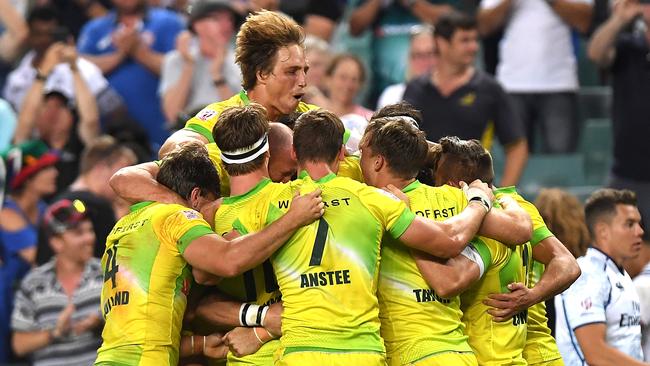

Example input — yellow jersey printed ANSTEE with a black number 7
[235,172,415,354]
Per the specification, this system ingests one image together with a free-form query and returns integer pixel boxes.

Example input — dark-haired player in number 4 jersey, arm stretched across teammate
[96,144,323,365]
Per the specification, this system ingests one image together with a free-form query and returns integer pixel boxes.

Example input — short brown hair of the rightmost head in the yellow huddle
[436,136,494,185]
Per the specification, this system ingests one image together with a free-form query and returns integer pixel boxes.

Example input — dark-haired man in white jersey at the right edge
[555,189,646,366]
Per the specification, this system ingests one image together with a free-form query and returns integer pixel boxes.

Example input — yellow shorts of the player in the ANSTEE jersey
[275,348,386,366]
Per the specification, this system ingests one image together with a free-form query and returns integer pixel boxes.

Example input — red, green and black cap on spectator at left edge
[1,140,59,189]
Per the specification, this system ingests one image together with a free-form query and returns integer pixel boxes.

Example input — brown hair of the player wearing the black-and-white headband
[212,103,270,175]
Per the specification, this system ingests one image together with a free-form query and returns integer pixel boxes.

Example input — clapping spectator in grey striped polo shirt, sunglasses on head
[11,200,104,365]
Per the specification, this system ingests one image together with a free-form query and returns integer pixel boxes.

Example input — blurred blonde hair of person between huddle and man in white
[535,188,591,258]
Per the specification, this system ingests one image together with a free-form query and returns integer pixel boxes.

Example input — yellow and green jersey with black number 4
[96,202,213,365]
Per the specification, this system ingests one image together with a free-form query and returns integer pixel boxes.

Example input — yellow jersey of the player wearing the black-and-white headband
[214,178,293,365]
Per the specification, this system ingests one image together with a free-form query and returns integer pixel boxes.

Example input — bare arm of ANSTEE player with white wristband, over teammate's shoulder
[399,180,494,258]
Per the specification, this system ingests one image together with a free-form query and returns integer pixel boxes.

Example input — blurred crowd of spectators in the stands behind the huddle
[0,0,650,364]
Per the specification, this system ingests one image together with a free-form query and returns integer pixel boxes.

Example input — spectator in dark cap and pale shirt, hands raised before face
[158,0,242,128]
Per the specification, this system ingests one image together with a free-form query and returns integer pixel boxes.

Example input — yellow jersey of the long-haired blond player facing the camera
[185,90,318,142]
